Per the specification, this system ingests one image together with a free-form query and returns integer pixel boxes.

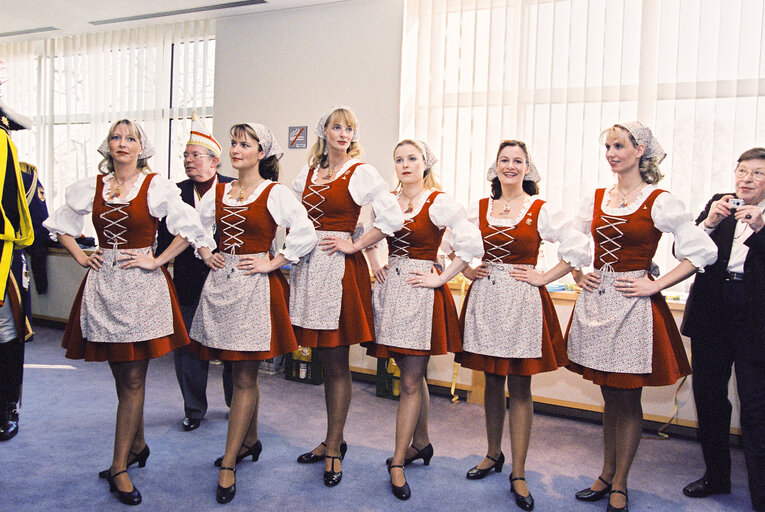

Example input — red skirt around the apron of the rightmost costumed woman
[566,293,691,389]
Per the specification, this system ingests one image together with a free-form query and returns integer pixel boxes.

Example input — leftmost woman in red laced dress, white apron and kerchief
[43,119,215,505]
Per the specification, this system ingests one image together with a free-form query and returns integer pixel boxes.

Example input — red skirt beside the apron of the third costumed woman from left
[293,252,375,348]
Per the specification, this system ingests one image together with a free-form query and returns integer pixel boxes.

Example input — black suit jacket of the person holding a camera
[681,194,765,360]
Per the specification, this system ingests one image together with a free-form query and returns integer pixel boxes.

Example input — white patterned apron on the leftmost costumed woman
[80,247,174,343]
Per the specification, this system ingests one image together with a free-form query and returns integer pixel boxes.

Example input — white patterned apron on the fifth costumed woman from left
[462,262,544,359]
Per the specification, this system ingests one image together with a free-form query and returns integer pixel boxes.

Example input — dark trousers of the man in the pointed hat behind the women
[173,305,234,419]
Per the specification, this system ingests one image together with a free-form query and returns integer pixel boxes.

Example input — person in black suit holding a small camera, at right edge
[681,148,765,511]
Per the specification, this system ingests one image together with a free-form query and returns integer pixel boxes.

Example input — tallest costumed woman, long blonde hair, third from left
[290,107,404,487]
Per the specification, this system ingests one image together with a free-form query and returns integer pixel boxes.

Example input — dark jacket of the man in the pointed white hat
[157,174,234,306]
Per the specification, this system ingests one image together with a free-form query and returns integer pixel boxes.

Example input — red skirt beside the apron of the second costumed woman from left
[188,270,298,361]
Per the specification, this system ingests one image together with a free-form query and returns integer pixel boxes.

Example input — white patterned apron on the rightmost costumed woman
[568,270,653,374]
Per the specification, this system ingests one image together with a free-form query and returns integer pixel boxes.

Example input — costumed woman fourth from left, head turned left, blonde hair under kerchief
[367,139,483,500]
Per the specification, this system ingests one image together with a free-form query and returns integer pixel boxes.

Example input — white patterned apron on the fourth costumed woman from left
[372,256,434,350]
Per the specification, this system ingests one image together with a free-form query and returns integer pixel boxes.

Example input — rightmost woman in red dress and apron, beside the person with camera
[567,122,717,512]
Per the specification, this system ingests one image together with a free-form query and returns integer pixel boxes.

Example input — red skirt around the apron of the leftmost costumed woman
[61,267,190,363]
